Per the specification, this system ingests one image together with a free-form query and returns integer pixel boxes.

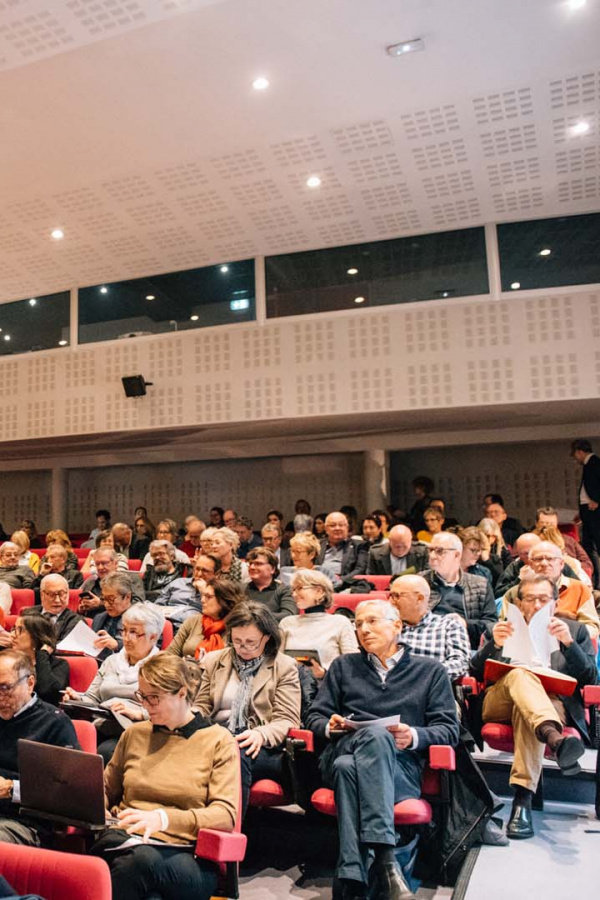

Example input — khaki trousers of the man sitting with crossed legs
[483,669,566,791]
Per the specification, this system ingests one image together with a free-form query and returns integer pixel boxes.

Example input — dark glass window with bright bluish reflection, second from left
[79,259,255,344]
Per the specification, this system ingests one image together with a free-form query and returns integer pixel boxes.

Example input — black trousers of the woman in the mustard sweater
[90,828,218,900]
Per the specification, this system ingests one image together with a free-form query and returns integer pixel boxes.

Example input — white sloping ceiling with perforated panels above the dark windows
[0,0,600,300]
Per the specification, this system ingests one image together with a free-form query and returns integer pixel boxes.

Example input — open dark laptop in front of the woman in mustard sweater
[18,738,107,831]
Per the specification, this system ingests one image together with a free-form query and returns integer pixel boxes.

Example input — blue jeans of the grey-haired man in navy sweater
[321,726,423,884]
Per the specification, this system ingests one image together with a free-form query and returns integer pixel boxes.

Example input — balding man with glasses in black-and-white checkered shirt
[390,575,471,681]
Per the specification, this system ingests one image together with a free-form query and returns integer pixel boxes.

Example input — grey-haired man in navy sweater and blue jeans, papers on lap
[307,600,459,900]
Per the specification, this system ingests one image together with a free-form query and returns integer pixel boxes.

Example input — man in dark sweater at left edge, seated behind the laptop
[0,650,81,844]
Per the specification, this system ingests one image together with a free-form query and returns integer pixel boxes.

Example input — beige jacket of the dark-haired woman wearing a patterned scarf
[193,647,300,747]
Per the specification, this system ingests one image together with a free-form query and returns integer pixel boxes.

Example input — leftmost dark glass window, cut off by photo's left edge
[0,291,71,356]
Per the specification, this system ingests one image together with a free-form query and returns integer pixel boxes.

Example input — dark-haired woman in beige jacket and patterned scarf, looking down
[194,602,301,811]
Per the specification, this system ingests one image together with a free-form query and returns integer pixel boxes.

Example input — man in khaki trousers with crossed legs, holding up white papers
[471,576,597,838]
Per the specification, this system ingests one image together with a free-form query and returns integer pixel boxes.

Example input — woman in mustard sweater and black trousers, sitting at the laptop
[92,654,239,900]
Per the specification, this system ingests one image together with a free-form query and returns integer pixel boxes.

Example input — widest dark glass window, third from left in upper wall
[265,228,489,317]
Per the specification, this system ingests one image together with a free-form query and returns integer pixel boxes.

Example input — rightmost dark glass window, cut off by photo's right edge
[498,213,600,291]
